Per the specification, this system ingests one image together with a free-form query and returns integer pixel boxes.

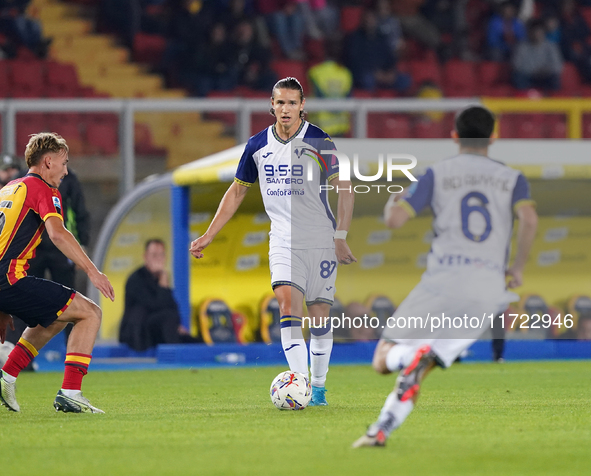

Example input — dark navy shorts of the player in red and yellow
[0,276,76,327]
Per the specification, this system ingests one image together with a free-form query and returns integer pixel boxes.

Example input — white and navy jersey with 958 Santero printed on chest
[234,121,339,249]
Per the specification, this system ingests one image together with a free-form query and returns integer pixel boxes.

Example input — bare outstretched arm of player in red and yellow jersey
[45,217,115,301]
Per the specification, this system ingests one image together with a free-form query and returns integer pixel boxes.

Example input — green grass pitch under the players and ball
[0,362,591,476]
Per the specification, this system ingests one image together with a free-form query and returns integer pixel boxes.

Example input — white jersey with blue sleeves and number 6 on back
[400,154,533,291]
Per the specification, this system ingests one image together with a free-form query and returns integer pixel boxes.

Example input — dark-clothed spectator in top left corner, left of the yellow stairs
[0,0,51,58]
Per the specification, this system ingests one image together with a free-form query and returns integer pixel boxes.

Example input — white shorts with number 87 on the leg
[269,247,337,306]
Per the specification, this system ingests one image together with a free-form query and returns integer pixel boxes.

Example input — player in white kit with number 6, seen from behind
[353,106,537,447]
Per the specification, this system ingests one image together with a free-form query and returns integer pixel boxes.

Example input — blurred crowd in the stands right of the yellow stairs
[91,0,591,97]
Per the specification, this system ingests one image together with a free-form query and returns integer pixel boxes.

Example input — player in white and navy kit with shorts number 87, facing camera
[190,77,357,406]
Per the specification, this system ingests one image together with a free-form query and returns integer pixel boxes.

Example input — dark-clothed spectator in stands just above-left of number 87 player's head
[232,21,277,91]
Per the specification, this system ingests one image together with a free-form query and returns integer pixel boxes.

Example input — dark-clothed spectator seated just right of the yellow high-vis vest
[345,10,411,92]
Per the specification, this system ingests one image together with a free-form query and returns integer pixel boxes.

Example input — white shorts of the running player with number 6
[382,284,513,367]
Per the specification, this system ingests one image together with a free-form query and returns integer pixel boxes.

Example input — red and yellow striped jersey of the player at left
[0,173,63,290]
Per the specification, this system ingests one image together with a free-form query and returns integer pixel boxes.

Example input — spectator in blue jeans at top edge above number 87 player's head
[256,0,306,60]
